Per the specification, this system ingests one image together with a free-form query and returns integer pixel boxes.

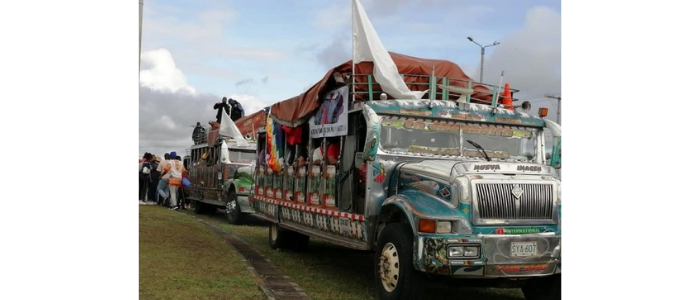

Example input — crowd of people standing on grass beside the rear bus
[139,151,187,210]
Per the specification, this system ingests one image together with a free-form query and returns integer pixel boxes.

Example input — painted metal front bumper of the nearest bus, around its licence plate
[414,233,561,278]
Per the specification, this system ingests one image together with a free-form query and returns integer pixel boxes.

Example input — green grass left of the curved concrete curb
[139,206,265,300]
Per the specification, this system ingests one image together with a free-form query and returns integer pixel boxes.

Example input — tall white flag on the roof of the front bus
[352,0,425,99]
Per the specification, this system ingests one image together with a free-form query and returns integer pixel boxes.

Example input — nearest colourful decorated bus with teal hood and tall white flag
[251,1,561,299]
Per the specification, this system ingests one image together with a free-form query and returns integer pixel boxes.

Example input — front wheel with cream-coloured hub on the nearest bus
[374,223,425,300]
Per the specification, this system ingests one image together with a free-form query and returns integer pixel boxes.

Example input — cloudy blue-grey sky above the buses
[139,0,561,156]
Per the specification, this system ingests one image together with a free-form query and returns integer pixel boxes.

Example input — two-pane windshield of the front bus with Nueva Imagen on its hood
[380,117,538,161]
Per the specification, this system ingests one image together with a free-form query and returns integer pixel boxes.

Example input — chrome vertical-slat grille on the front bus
[476,183,554,220]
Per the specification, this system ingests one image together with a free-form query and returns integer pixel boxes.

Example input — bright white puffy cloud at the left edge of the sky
[140,48,196,93]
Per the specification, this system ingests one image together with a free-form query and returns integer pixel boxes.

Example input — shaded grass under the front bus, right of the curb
[192,214,524,300]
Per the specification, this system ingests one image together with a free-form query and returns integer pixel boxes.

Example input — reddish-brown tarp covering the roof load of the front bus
[270,52,492,127]
